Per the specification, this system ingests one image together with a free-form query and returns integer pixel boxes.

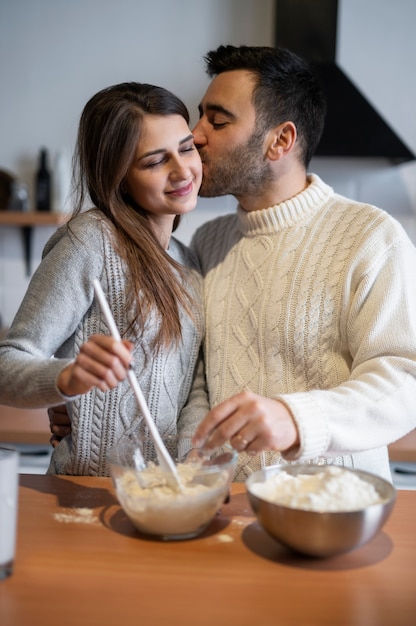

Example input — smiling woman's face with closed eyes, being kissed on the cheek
[126,115,202,225]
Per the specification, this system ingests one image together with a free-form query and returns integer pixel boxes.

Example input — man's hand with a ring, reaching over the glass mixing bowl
[192,391,299,454]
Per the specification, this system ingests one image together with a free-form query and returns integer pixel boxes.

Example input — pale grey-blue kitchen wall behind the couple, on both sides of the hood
[0,0,416,325]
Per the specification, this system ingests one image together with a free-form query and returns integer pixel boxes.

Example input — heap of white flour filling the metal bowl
[250,466,384,512]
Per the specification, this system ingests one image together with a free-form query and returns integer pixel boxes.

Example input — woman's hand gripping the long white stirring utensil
[57,335,133,396]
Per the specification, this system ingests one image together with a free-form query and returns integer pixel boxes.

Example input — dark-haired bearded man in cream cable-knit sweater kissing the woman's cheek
[52,46,416,481]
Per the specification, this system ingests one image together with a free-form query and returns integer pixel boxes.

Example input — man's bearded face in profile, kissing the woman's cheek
[193,70,271,199]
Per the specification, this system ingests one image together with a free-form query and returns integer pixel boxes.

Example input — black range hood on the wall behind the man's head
[275,0,416,163]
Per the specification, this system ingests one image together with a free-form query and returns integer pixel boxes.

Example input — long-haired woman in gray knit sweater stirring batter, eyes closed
[0,83,208,476]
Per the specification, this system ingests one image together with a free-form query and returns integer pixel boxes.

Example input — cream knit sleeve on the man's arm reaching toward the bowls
[278,232,416,459]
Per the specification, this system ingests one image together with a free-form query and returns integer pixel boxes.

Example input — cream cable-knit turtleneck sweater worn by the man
[192,175,416,481]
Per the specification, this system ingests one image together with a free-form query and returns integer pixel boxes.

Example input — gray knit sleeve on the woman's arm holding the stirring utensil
[0,216,107,408]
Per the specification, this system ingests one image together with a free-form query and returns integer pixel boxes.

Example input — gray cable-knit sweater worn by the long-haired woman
[0,210,207,476]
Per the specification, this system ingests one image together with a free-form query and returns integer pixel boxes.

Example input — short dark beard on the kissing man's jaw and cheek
[199,125,272,198]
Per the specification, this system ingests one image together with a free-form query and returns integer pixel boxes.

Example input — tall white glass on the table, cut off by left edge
[0,446,19,580]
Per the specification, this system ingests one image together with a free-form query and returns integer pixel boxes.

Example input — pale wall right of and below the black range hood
[311,0,416,242]
